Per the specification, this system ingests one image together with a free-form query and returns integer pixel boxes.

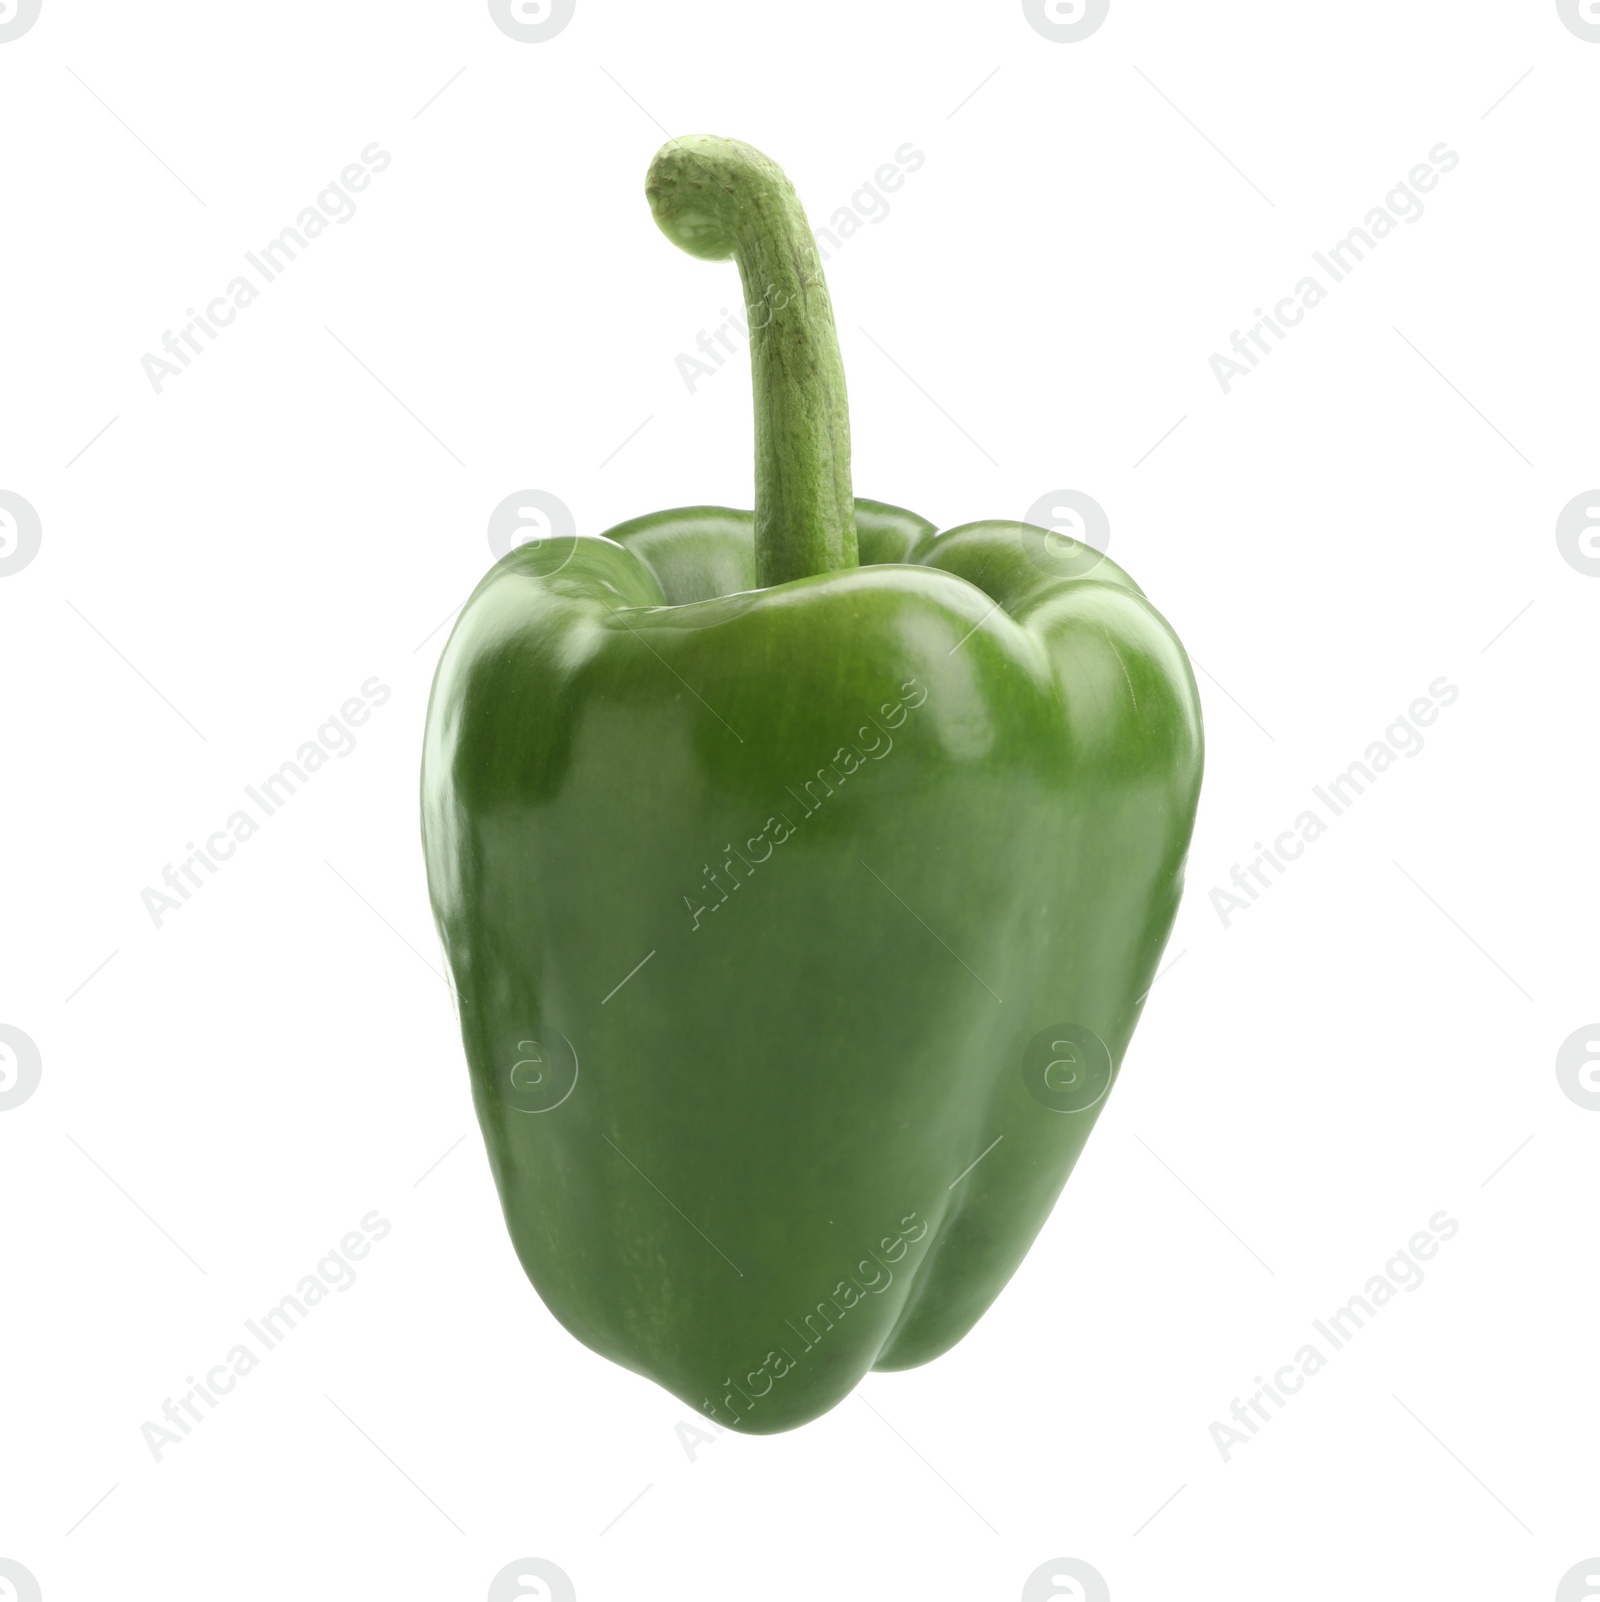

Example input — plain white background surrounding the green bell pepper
[0,0,1600,1602]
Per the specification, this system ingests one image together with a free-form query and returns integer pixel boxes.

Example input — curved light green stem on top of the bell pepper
[645,136,858,588]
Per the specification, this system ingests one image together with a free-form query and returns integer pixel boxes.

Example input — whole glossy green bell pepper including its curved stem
[423,139,1201,1432]
